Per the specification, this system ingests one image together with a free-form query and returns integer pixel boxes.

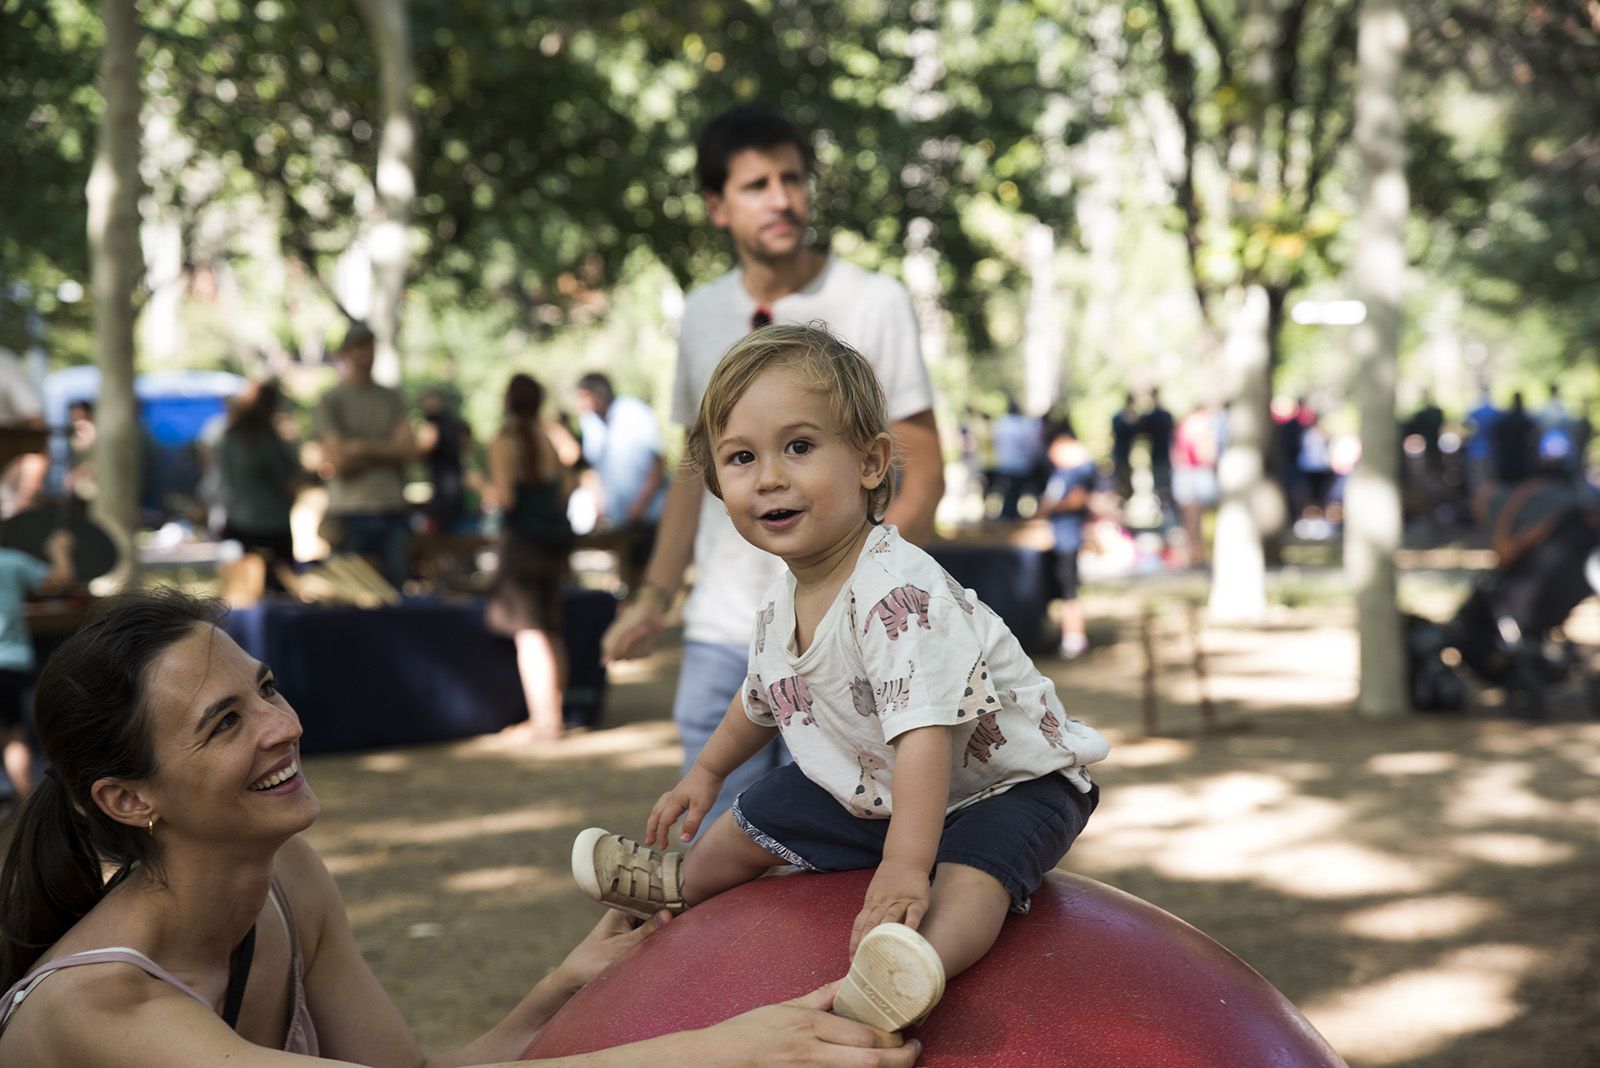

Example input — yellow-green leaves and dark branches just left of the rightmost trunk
[1126,0,1358,327]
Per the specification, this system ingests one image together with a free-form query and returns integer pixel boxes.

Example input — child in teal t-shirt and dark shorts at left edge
[0,531,74,801]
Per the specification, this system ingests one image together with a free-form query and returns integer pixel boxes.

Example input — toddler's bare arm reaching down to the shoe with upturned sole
[850,726,954,953]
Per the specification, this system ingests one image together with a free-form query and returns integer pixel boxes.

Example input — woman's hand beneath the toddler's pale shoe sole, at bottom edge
[701,983,922,1068]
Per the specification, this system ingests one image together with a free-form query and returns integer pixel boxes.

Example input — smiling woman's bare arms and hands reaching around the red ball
[9,839,918,1068]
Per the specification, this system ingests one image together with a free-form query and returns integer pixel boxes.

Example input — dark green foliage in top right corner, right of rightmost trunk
[1410,0,1600,371]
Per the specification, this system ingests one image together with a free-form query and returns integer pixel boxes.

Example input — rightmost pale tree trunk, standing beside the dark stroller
[1344,0,1410,718]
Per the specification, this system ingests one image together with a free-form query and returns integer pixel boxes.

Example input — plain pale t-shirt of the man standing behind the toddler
[672,256,933,644]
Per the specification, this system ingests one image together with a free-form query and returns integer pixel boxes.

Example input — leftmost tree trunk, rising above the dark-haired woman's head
[86,0,144,588]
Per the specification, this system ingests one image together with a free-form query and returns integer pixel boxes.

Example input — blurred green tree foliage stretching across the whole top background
[0,0,1600,415]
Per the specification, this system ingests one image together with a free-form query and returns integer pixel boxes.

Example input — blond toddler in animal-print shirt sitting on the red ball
[573,325,1107,1031]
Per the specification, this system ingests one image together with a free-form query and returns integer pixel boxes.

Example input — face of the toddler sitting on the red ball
[712,368,890,568]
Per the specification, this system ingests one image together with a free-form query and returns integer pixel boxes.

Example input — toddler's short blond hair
[683,323,894,523]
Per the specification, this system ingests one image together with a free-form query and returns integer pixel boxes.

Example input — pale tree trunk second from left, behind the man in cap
[358,0,416,385]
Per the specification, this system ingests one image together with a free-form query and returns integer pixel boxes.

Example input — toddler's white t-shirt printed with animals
[744,526,1110,819]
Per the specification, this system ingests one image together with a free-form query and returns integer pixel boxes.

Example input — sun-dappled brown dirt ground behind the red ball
[307,577,1600,1068]
